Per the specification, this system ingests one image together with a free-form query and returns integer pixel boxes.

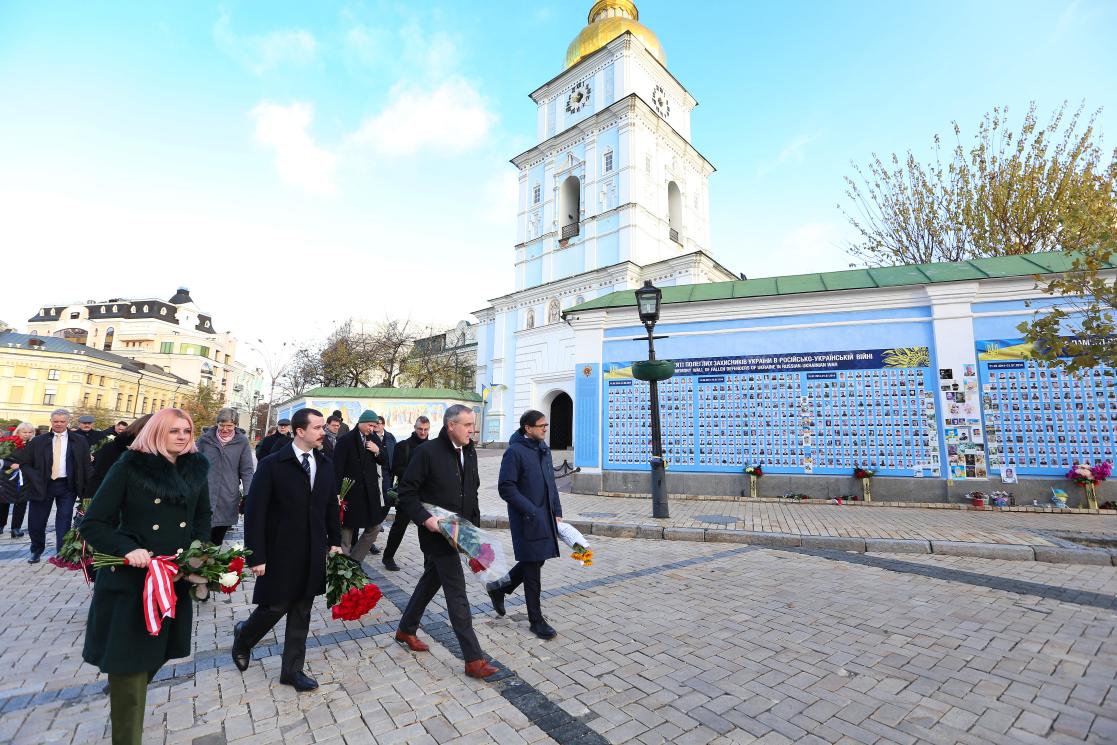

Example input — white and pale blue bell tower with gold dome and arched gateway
[474,0,736,449]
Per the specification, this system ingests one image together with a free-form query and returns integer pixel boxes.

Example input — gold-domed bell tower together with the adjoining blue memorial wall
[475,0,1117,502]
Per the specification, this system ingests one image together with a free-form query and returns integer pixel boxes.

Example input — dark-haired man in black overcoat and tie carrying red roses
[232,409,342,691]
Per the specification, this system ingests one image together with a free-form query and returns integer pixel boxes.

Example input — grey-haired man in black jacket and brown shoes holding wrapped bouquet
[395,403,497,678]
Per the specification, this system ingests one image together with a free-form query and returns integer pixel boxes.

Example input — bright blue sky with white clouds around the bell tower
[0,0,1117,357]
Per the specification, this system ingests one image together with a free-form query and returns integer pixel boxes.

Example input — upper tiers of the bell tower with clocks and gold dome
[512,0,714,290]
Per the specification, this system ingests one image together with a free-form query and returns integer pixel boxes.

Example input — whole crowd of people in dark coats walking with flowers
[0,404,562,743]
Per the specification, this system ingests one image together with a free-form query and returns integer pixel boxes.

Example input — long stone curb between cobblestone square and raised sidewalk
[481,515,1117,566]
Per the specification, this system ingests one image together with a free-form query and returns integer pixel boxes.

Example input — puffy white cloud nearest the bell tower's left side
[350,78,496,155]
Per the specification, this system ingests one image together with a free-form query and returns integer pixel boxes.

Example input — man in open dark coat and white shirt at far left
[10,409,93,564]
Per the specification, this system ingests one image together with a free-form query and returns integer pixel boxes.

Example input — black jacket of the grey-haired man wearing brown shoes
[395,427,481,554]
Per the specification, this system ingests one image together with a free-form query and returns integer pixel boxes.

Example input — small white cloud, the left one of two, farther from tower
[251,102,337,194]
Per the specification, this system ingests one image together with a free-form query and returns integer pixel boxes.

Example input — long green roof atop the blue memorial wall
[563,251,1117,315]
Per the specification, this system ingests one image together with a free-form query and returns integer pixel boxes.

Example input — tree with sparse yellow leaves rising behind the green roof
[840,103,1117,266]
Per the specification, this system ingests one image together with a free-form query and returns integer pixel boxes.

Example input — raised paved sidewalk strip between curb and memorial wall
[466,450,1117,546]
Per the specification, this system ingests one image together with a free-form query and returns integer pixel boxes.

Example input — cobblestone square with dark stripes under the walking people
[0,508,1117,745]
